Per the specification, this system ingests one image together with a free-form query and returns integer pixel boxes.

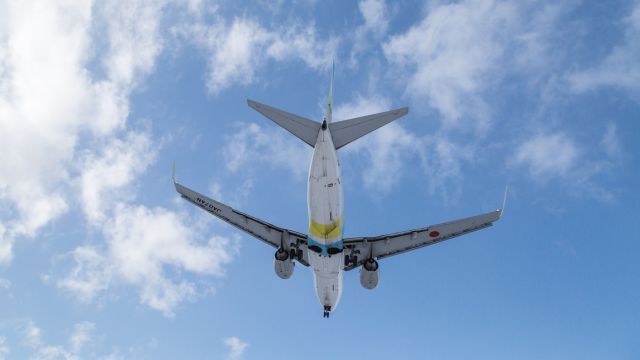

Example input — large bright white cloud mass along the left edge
[0,0,240,316]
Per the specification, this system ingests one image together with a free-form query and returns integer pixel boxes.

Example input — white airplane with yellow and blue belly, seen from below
[173,67,507,318]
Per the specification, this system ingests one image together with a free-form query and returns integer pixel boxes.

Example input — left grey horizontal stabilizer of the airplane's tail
[247,100,320,147]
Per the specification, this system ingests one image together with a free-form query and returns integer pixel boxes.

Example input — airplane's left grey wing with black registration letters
[174,180,309,266]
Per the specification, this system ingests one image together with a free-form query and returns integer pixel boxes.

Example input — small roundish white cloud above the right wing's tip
[513,133,580,181]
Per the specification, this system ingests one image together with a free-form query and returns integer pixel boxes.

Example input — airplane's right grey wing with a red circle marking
[344,209,502,270]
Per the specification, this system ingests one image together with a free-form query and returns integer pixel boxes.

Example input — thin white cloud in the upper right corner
[568,3,640,93]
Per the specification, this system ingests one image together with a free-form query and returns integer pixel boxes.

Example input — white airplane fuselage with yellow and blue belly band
[307,127,344,310]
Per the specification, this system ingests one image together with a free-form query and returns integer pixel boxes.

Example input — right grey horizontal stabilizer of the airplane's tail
[329,107,409,149]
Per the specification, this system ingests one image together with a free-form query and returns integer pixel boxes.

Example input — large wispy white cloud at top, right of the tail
[383,0,518,130]
